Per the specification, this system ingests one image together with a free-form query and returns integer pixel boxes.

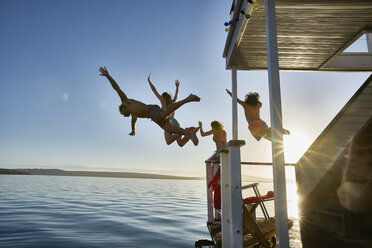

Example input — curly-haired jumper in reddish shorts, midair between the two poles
[226,89,289,141]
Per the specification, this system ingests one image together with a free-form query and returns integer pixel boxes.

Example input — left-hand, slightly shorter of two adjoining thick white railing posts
[220,152,231,248]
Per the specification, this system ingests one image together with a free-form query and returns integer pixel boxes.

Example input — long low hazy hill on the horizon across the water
[17,169,202,180]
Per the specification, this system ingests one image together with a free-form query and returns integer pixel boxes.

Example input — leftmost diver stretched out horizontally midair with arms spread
[99,67,200,146]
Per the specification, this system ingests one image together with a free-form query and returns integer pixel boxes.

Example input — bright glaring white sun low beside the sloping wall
[284,129,312,163]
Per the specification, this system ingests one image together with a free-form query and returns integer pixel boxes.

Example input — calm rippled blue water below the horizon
[0,175,301,248]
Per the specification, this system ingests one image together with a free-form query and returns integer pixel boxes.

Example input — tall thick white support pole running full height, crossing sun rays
[265,0,289,248]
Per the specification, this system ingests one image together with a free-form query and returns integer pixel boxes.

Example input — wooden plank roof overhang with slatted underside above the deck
[223,0,372,71]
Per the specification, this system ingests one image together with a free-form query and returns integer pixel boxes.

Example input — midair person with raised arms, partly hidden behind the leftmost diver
[147,73,199,147]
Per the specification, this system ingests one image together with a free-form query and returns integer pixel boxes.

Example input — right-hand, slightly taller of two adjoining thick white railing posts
[228,142,243,248]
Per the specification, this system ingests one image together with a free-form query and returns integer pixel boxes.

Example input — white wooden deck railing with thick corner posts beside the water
[205,140,295,248]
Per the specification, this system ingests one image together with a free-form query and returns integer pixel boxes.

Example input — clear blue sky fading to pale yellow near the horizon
[0,0,369,177]
